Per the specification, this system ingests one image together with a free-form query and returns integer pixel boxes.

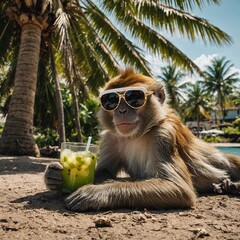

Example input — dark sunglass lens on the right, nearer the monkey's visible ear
[125,90,145,108]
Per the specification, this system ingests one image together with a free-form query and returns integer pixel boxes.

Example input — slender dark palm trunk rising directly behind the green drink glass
[49,41,66,147]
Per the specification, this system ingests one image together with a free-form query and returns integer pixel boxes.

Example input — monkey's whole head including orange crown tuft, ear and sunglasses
[98,69,166,137]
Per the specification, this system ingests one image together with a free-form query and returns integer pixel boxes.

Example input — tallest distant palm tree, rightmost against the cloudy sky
[204,57,239,121]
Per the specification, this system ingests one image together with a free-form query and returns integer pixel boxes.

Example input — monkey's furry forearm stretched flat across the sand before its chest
[66,178,196,212]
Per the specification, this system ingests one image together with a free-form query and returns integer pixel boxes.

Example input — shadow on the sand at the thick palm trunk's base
[0,156,58,175]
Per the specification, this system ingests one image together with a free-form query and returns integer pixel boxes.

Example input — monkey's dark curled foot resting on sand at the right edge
[213,179,240,194]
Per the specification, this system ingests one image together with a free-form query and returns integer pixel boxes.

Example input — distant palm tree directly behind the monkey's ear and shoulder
[158,65,188,112]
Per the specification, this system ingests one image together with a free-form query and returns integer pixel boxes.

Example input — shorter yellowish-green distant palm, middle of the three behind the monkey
[182,81,213,134]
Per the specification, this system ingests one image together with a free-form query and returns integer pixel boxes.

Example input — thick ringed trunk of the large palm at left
[0,23,41,156]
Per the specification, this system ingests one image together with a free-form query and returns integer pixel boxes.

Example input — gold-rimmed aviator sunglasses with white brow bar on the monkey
[100,87,153,111]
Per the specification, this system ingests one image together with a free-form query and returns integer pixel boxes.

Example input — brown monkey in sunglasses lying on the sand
[45,69,240,212]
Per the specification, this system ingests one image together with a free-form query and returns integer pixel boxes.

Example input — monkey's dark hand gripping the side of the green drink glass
[44,162,64,191]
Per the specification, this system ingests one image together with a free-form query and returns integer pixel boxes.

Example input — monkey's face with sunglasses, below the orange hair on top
[99,87,166,137]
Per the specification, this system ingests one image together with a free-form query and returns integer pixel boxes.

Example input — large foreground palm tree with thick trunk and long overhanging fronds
[0,0,231,155]
